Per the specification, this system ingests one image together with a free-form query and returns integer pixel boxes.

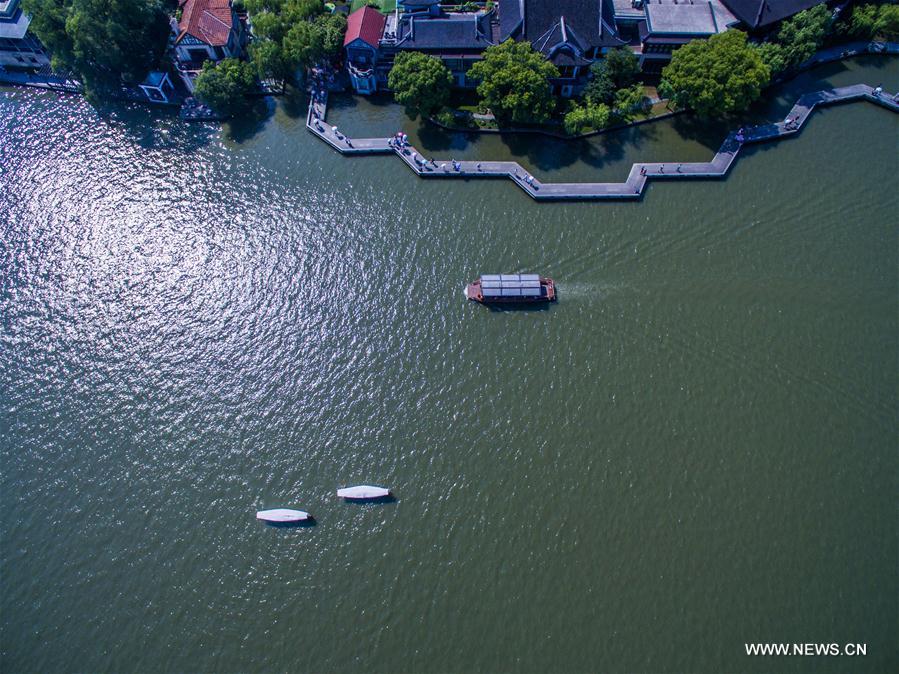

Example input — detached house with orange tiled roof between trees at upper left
[175,0,246,65]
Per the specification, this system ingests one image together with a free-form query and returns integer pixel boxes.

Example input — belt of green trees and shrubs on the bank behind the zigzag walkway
[388,0,899,136]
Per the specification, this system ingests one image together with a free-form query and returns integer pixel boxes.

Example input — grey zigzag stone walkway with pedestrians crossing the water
[306,84,899,201]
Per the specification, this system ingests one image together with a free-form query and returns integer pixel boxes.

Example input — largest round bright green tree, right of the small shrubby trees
[659,30,771,117]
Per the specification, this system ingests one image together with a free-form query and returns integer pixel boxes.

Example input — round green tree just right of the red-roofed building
[387,52,453,119]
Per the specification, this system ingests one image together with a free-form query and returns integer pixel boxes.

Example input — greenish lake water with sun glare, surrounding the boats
[0,58,899,672]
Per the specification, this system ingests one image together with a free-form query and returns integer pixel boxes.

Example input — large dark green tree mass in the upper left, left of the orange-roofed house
[24,0,171,95]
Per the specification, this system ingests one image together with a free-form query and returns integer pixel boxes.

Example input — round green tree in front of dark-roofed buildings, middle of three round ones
[469,40,559,123]
